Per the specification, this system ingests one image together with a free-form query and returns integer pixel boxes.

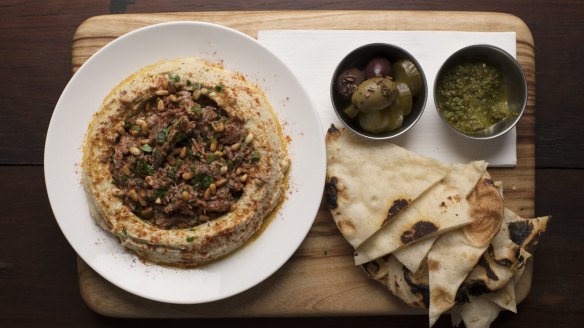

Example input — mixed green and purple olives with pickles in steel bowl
[335,57,422,133]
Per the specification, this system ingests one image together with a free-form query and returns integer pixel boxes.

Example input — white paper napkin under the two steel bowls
[258,30,517,167]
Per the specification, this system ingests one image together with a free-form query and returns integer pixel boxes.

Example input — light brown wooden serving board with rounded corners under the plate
[73,11,535,317]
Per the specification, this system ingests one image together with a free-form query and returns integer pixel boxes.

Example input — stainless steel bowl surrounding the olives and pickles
[330,43,428,140]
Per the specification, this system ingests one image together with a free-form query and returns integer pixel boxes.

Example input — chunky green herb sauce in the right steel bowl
[436,60,516,132]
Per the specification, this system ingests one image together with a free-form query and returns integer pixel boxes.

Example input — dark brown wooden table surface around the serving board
[0,0,584,327]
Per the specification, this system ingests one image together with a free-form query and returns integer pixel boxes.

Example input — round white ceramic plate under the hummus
[45,22,326,304]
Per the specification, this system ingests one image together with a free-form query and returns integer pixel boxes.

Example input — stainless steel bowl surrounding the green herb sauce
[434,44,527,140]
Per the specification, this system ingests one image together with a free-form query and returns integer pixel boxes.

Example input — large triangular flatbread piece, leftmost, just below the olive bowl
[325,126,451,249]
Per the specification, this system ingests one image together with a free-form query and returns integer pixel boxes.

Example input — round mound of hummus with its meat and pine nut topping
[83,58,289,267]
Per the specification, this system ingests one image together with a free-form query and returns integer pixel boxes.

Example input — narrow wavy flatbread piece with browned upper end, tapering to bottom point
[427,174,503,327]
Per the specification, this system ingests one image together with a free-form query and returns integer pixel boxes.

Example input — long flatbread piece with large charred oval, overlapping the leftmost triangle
[355,161,486,266]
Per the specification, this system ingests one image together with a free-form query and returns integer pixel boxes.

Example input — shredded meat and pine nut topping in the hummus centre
[105,75,259,229]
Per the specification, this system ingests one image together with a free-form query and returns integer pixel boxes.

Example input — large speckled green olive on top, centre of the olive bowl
[351,77,397,112]
